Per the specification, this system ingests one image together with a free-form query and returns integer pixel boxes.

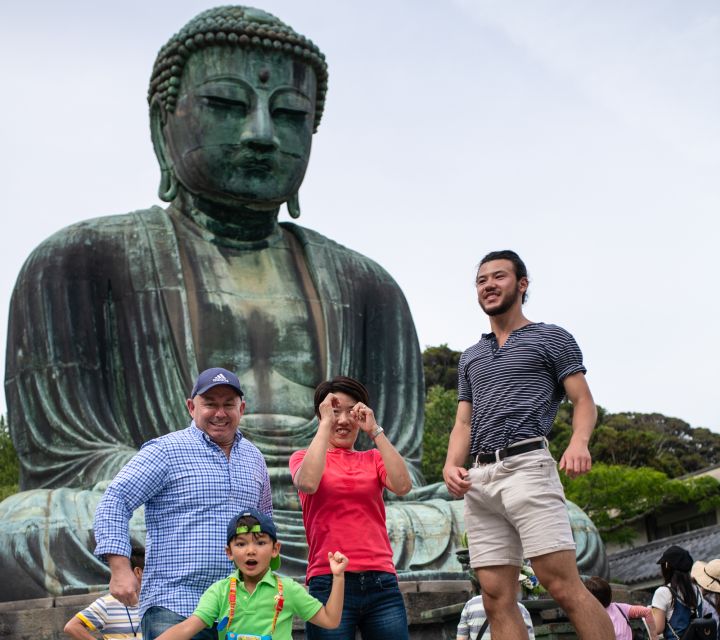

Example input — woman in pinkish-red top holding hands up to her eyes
[290,376,412,640]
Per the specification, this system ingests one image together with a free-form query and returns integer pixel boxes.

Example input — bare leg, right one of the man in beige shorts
[528,551,615,640]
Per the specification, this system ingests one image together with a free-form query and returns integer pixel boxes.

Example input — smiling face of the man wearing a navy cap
[187,384,245,446]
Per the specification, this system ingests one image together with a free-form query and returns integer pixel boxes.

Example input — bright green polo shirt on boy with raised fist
[193,570,323,640]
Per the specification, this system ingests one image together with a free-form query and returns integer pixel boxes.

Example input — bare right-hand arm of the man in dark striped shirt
[559,372,597,478]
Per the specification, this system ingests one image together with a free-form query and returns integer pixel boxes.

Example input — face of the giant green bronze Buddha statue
[163,47,316,209]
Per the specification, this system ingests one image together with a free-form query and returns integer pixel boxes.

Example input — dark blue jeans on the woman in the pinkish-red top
[305,571,408,640]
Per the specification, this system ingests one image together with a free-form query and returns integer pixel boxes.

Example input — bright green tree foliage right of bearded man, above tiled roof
[561,463,720,543]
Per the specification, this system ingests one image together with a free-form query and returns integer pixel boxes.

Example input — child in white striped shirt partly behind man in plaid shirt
[64,549,145,640]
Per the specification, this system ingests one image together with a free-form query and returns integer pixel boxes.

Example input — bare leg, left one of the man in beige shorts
[475,566,528,640]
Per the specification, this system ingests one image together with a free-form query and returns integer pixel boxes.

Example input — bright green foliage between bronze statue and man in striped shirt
[421,385,457,482]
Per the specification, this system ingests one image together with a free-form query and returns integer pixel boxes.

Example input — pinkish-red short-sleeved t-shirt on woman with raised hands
[290,449,395,580]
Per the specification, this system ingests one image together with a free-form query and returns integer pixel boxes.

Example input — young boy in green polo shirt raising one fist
[157,509,348,640]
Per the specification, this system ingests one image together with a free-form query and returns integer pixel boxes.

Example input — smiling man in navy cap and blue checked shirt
[94,368,272,640]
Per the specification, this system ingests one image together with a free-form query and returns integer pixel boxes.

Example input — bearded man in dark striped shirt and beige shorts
[443,250,614,640]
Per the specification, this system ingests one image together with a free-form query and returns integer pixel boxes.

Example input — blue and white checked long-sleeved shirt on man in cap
[94,422,272,616]
